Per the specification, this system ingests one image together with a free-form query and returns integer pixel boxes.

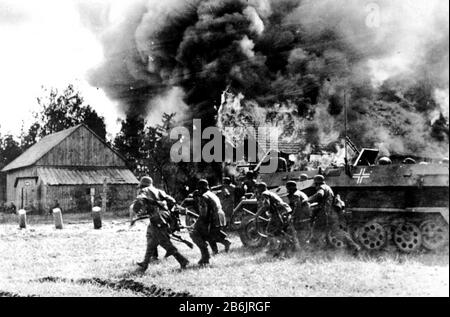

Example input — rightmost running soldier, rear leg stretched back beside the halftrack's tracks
[308,175,361,255]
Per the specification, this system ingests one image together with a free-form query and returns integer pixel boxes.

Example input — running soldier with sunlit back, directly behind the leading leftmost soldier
[191,179,231,265]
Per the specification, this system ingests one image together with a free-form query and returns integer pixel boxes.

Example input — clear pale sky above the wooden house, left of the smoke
[0,0,123,135]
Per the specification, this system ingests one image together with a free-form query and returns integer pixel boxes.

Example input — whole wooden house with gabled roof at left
[2,124,138,213]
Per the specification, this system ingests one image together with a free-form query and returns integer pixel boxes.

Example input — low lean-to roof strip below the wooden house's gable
[38,167,139,185]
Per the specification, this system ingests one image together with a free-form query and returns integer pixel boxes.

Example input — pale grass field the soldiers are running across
[0,215,449,297]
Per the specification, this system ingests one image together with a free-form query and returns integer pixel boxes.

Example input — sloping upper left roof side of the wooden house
[2,124,82,172]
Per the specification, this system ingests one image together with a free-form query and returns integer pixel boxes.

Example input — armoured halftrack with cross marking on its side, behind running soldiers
[232,149,449,253]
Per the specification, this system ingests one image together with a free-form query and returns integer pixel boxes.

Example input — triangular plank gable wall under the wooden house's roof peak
[36,127,125,167]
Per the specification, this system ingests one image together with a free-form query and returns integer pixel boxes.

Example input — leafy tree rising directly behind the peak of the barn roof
[21,85,106,149]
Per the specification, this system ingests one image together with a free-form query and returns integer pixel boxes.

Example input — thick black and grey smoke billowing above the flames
[80,0,449,155]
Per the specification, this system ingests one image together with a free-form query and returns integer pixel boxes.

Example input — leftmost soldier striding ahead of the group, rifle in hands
[133,176,189,271]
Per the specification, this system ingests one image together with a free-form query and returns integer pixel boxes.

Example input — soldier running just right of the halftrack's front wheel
[256,183,300,257]
